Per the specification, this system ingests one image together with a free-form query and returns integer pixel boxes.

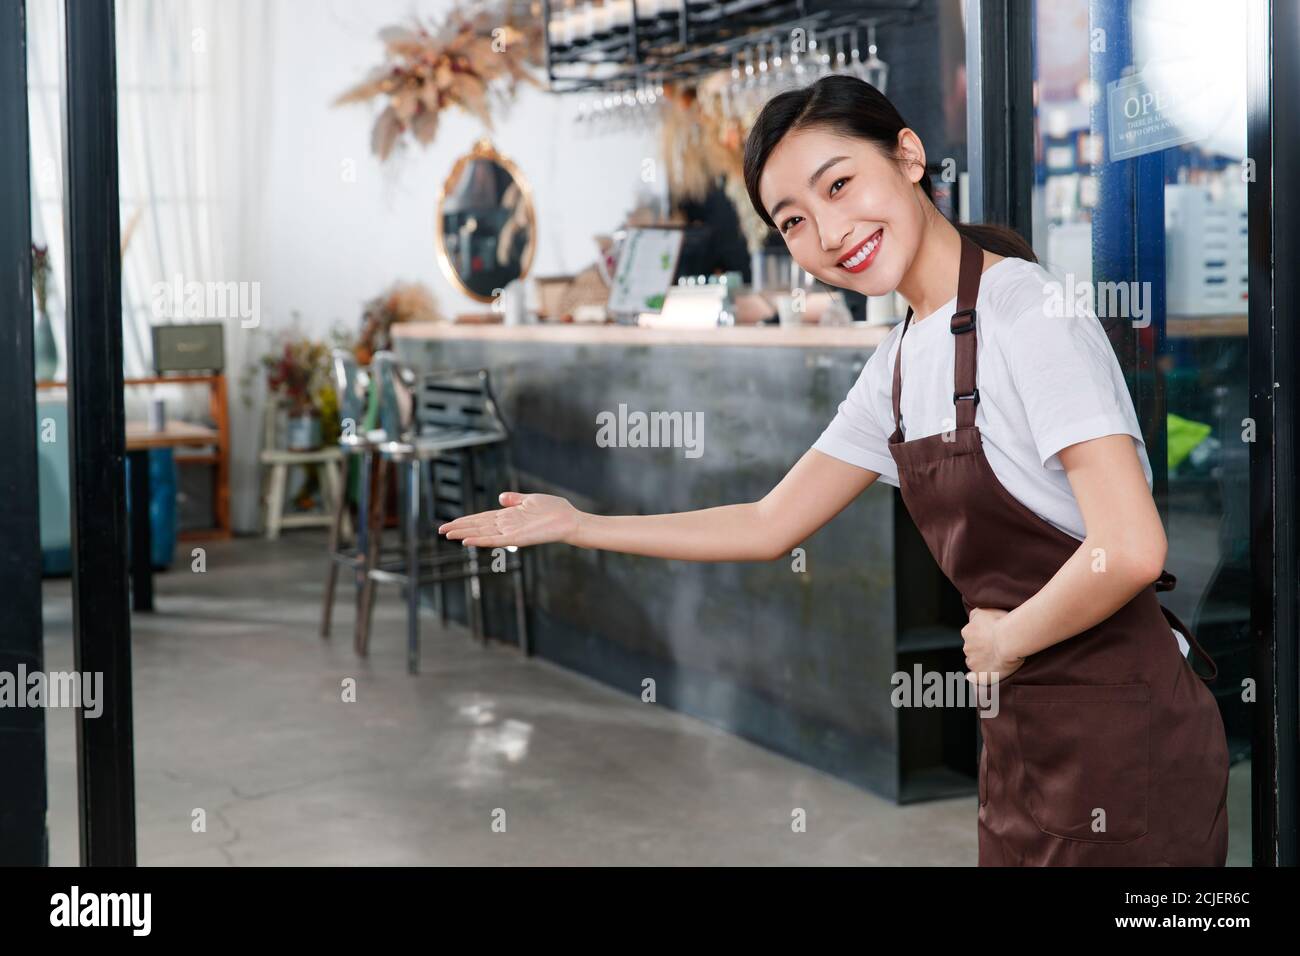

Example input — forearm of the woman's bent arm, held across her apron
[997,540,1160,657]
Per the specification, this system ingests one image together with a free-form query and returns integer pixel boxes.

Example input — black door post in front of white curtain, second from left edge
[64,0,135,866]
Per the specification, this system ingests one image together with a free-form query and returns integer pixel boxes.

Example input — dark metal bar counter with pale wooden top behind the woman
[393,324,978,803]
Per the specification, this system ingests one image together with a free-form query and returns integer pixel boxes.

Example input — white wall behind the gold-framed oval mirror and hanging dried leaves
[263,0,658,330]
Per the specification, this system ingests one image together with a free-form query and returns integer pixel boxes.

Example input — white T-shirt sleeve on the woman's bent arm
[1006,303,1149,477]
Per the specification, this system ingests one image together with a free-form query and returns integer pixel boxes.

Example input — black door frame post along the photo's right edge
[1247,0,1300,866]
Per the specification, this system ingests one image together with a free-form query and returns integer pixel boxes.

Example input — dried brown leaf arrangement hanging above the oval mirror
[334,0,545,161]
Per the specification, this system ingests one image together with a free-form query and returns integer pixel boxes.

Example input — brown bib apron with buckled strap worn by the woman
[889,237,1229,866]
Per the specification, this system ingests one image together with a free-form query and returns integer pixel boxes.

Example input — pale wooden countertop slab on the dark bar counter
[393,323,893,349]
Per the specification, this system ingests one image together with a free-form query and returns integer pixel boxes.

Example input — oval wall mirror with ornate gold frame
[437,139,537,302]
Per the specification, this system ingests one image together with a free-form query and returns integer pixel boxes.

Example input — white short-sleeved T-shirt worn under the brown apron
[813,259,1188,654]
